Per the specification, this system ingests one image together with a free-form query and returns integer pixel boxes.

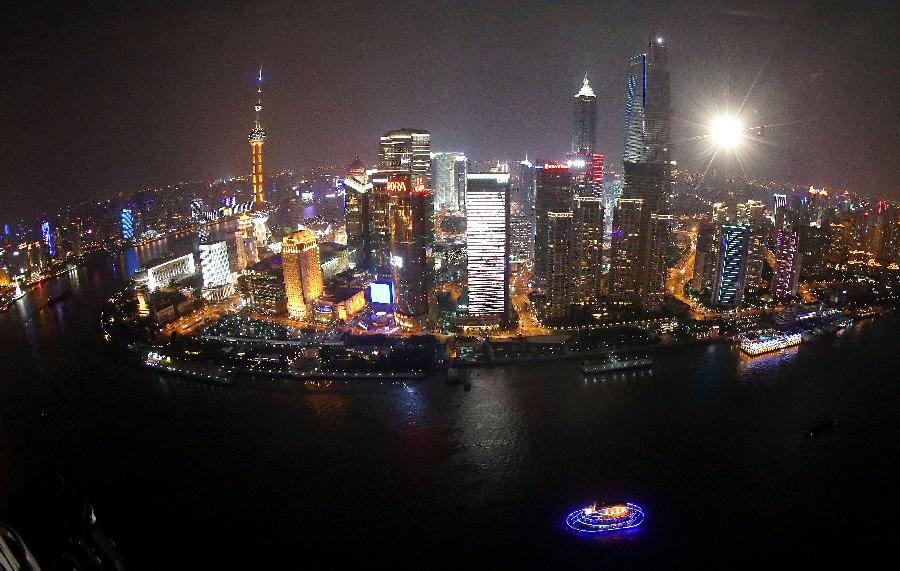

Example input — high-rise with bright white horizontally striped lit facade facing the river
[466,173,510,325]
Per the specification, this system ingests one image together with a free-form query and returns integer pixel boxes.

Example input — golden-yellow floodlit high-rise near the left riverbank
[281,230,324,319]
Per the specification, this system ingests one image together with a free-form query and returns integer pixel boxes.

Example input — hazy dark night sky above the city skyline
[0,0,900,218]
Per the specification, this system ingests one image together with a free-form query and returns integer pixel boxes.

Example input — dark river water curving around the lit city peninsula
[0,223,900,569]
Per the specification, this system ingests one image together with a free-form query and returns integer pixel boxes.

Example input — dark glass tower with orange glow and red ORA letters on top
[379,173,434,326]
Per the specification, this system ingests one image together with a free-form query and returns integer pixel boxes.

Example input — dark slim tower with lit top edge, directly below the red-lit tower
[572,196,603,306]
